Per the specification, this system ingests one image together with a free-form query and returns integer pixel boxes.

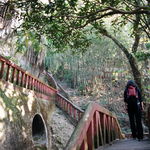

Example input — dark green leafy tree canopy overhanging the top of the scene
[13,0,149,51]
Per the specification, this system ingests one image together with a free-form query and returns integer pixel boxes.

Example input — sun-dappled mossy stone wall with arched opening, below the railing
[0,80,55,150]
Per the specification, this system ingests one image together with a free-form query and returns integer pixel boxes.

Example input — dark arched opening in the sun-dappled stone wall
[32,114,47,149]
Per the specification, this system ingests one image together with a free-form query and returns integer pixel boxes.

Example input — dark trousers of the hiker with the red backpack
[128,105,143,139]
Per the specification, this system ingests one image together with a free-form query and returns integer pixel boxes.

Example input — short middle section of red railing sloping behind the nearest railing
[56,94,84,123]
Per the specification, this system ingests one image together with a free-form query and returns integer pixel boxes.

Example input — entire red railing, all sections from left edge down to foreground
[0,56,123,150]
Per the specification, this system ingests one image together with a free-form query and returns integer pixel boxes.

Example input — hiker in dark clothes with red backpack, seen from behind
[124,80,143,140]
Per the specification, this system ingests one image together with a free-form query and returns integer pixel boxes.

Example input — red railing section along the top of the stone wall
[0,55,57,96]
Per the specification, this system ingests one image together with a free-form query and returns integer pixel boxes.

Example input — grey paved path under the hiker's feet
[98,139,150,150]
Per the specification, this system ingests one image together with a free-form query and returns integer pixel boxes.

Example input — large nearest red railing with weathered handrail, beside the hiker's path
[65,103,123,150]
